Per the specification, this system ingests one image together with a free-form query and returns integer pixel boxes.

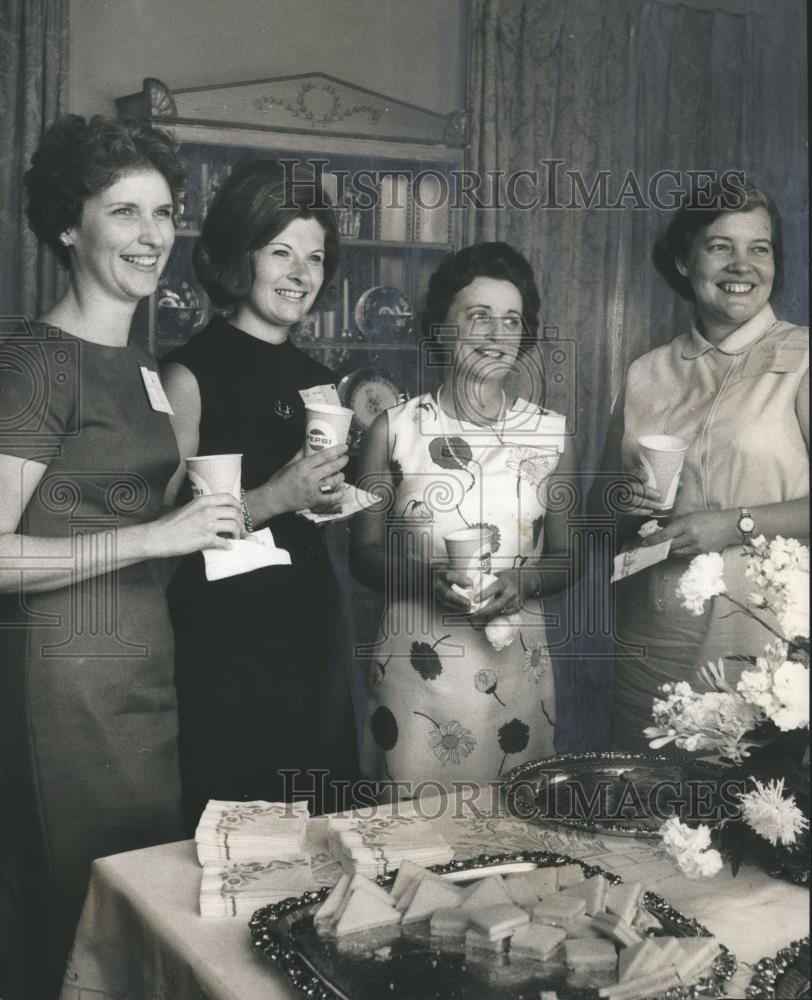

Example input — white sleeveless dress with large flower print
[362,394,565,787]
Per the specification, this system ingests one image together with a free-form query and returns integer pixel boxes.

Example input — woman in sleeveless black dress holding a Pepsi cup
[165,160,355,834]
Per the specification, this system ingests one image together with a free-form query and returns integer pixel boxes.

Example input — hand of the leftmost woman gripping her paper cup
[143,493,245,558]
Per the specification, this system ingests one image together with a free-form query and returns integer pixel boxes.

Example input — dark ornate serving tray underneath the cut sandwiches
[249,851,736,1000]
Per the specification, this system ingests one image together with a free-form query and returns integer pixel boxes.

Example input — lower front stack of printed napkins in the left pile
[200,854,316,917]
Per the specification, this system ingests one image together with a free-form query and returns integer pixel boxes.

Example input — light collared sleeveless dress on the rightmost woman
[614,305,809,751]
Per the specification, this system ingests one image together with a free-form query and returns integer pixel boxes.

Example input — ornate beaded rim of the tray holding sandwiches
[248,851,737,1000]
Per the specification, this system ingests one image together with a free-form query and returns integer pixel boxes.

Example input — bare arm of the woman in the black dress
[161,362,348,527]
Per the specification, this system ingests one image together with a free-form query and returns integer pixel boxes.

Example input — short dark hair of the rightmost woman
[651,181,784,302]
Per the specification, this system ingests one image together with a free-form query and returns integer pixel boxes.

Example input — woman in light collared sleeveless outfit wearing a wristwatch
[609,184,809,750]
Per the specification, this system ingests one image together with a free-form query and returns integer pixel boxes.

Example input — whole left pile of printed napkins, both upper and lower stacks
[195,800,316,917]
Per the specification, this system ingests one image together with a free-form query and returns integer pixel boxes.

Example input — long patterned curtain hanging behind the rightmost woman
[465,0,808,751]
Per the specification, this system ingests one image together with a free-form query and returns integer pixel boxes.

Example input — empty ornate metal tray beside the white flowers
[501,753,725,838]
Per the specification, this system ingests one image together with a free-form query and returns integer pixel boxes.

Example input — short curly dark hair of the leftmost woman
[23,115,186,268]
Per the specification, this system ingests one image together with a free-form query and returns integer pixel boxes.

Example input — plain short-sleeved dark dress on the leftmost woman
[0,326,183,1000]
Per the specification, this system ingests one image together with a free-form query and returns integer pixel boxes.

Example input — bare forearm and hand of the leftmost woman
[0,454,241,593]
